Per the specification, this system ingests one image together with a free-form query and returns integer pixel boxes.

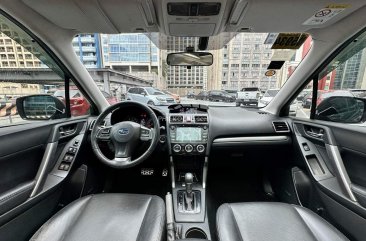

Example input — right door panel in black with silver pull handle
[293,120,366,240]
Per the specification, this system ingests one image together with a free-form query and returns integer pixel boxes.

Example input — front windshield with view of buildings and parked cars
[73,33,311,107]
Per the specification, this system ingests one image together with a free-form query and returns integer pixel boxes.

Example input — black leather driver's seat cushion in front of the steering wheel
[31,194,165,241]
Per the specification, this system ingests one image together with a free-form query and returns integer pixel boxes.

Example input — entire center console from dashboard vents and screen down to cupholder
[167,104,210,239]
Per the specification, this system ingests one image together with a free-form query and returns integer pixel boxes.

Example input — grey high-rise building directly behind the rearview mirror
[166,36,208,95]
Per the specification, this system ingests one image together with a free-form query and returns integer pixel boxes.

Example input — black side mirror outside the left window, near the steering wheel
[16,95,66,120]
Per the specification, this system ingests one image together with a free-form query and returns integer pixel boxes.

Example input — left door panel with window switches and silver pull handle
[0,118,88,240]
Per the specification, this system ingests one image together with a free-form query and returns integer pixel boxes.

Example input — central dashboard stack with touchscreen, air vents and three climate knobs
[168,105,209,155]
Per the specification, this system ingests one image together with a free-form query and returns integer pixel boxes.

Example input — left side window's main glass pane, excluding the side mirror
[0,14,65,127]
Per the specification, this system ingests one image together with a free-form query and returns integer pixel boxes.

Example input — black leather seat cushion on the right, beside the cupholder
[216,203,348,241]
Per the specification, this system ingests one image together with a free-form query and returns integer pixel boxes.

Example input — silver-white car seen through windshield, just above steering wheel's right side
[126,87,176,105]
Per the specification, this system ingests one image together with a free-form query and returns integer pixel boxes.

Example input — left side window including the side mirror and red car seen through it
[0,14,90,127]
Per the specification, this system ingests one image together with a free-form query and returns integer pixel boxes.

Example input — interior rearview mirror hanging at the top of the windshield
[166,52,213,66]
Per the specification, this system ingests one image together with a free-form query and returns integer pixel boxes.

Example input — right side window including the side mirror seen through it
[296,29,366,125]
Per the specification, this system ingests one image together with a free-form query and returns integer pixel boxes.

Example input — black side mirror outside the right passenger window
[315,96,366,123]
